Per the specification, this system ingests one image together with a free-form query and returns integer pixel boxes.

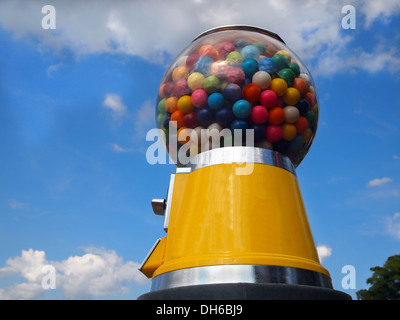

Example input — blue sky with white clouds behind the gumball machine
[0,0,400,299]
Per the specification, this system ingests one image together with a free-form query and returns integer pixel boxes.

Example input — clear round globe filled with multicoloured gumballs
[156,26,318,167]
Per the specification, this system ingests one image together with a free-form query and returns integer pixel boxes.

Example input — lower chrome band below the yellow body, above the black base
[150,265,332,291]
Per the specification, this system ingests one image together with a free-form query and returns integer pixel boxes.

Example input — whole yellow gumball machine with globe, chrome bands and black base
[139,26,349,299]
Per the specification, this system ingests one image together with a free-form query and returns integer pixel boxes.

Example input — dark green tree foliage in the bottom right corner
[356,255,400,300]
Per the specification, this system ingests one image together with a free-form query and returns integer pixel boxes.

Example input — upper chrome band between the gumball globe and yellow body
[189,147,296,175]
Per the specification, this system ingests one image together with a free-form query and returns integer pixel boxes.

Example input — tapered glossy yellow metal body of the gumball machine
[142,154,329,278]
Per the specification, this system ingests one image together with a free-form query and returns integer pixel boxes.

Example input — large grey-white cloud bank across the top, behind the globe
[0,0,400,75]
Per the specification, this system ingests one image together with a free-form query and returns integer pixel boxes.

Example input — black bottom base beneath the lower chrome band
[138,283,351,300]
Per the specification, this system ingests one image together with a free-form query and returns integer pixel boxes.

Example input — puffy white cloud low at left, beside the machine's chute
[0,247,147,299]
